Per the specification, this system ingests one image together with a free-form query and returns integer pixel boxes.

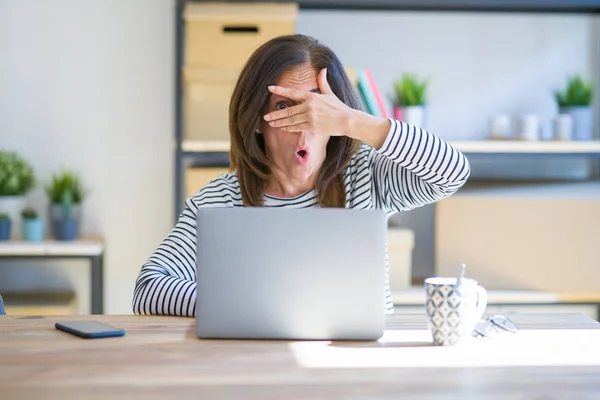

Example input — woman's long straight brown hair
[229,35,361,207]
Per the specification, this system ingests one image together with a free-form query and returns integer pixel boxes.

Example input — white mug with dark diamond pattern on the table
[425,277,487,346]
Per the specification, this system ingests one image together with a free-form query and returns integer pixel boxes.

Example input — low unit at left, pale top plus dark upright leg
[0,238,104,314]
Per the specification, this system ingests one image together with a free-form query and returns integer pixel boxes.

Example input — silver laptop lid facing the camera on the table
[196,207,387,340]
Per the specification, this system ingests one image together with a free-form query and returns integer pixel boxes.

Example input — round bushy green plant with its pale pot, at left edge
[0,150,35,238]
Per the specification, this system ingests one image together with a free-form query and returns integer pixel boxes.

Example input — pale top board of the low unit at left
[0,239,104,257]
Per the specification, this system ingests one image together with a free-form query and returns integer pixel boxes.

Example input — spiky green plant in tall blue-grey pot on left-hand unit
[46,171,85,240]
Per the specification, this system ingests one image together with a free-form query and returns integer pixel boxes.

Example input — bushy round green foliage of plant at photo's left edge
[0,151,35,196]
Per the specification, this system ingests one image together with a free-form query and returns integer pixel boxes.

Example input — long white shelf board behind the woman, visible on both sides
[181,140,600,155]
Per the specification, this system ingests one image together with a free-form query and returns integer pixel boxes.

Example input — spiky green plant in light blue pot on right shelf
[554,75,594,140]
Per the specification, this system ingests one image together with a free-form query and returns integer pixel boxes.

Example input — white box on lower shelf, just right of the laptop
[387,227,415,290]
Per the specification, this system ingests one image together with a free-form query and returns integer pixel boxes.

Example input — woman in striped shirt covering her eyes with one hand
[133,35,470,316]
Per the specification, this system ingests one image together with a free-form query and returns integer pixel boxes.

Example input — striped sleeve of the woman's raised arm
[369,119,471,212]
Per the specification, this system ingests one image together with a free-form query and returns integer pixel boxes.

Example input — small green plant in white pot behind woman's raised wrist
[394,74,429,128]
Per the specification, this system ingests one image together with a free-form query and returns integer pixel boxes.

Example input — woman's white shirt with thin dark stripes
[133,119,470,317]
